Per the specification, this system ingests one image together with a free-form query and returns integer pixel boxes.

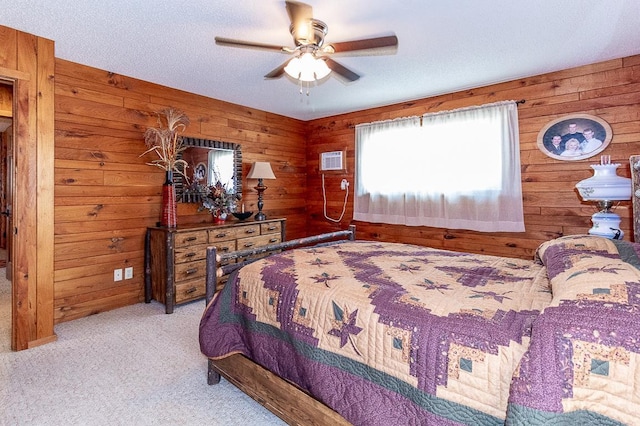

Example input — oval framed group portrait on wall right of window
[538,114,613,161]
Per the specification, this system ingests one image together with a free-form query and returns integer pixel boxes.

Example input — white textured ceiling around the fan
[0,0,640,120]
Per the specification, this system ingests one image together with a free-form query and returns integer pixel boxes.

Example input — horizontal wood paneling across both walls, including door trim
[7,20,640,349]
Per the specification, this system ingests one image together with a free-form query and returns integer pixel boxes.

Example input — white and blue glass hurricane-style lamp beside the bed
[576,155,631,239]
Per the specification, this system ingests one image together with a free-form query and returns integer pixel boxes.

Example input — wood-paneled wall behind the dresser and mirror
[54,59,306,322]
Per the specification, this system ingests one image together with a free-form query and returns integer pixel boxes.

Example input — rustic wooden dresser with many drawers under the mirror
[144,219,286,314]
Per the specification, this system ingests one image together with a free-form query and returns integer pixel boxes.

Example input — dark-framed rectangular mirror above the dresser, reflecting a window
[174,137,242,203]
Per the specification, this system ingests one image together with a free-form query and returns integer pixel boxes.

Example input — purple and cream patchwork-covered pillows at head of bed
[507,236,640,425]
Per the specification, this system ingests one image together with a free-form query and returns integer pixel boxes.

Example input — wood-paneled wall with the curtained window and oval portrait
[307,56,640,258]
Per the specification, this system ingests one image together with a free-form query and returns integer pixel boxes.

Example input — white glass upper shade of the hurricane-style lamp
[576,164,631,201]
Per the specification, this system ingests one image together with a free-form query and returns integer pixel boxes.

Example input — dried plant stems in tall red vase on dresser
[140,108,189,180]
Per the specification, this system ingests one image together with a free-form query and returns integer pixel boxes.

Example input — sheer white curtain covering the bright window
[354,102,524,232]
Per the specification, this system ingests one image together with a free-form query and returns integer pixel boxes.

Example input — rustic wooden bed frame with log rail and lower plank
[206,225,355,426]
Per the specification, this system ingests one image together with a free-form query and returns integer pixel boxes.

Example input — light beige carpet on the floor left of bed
[0,269,284,426]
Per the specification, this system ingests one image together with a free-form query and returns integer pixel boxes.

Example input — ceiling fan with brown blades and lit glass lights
[215,1,398,82]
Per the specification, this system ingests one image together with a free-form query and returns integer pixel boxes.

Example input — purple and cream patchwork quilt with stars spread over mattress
[200,241,552,425]
